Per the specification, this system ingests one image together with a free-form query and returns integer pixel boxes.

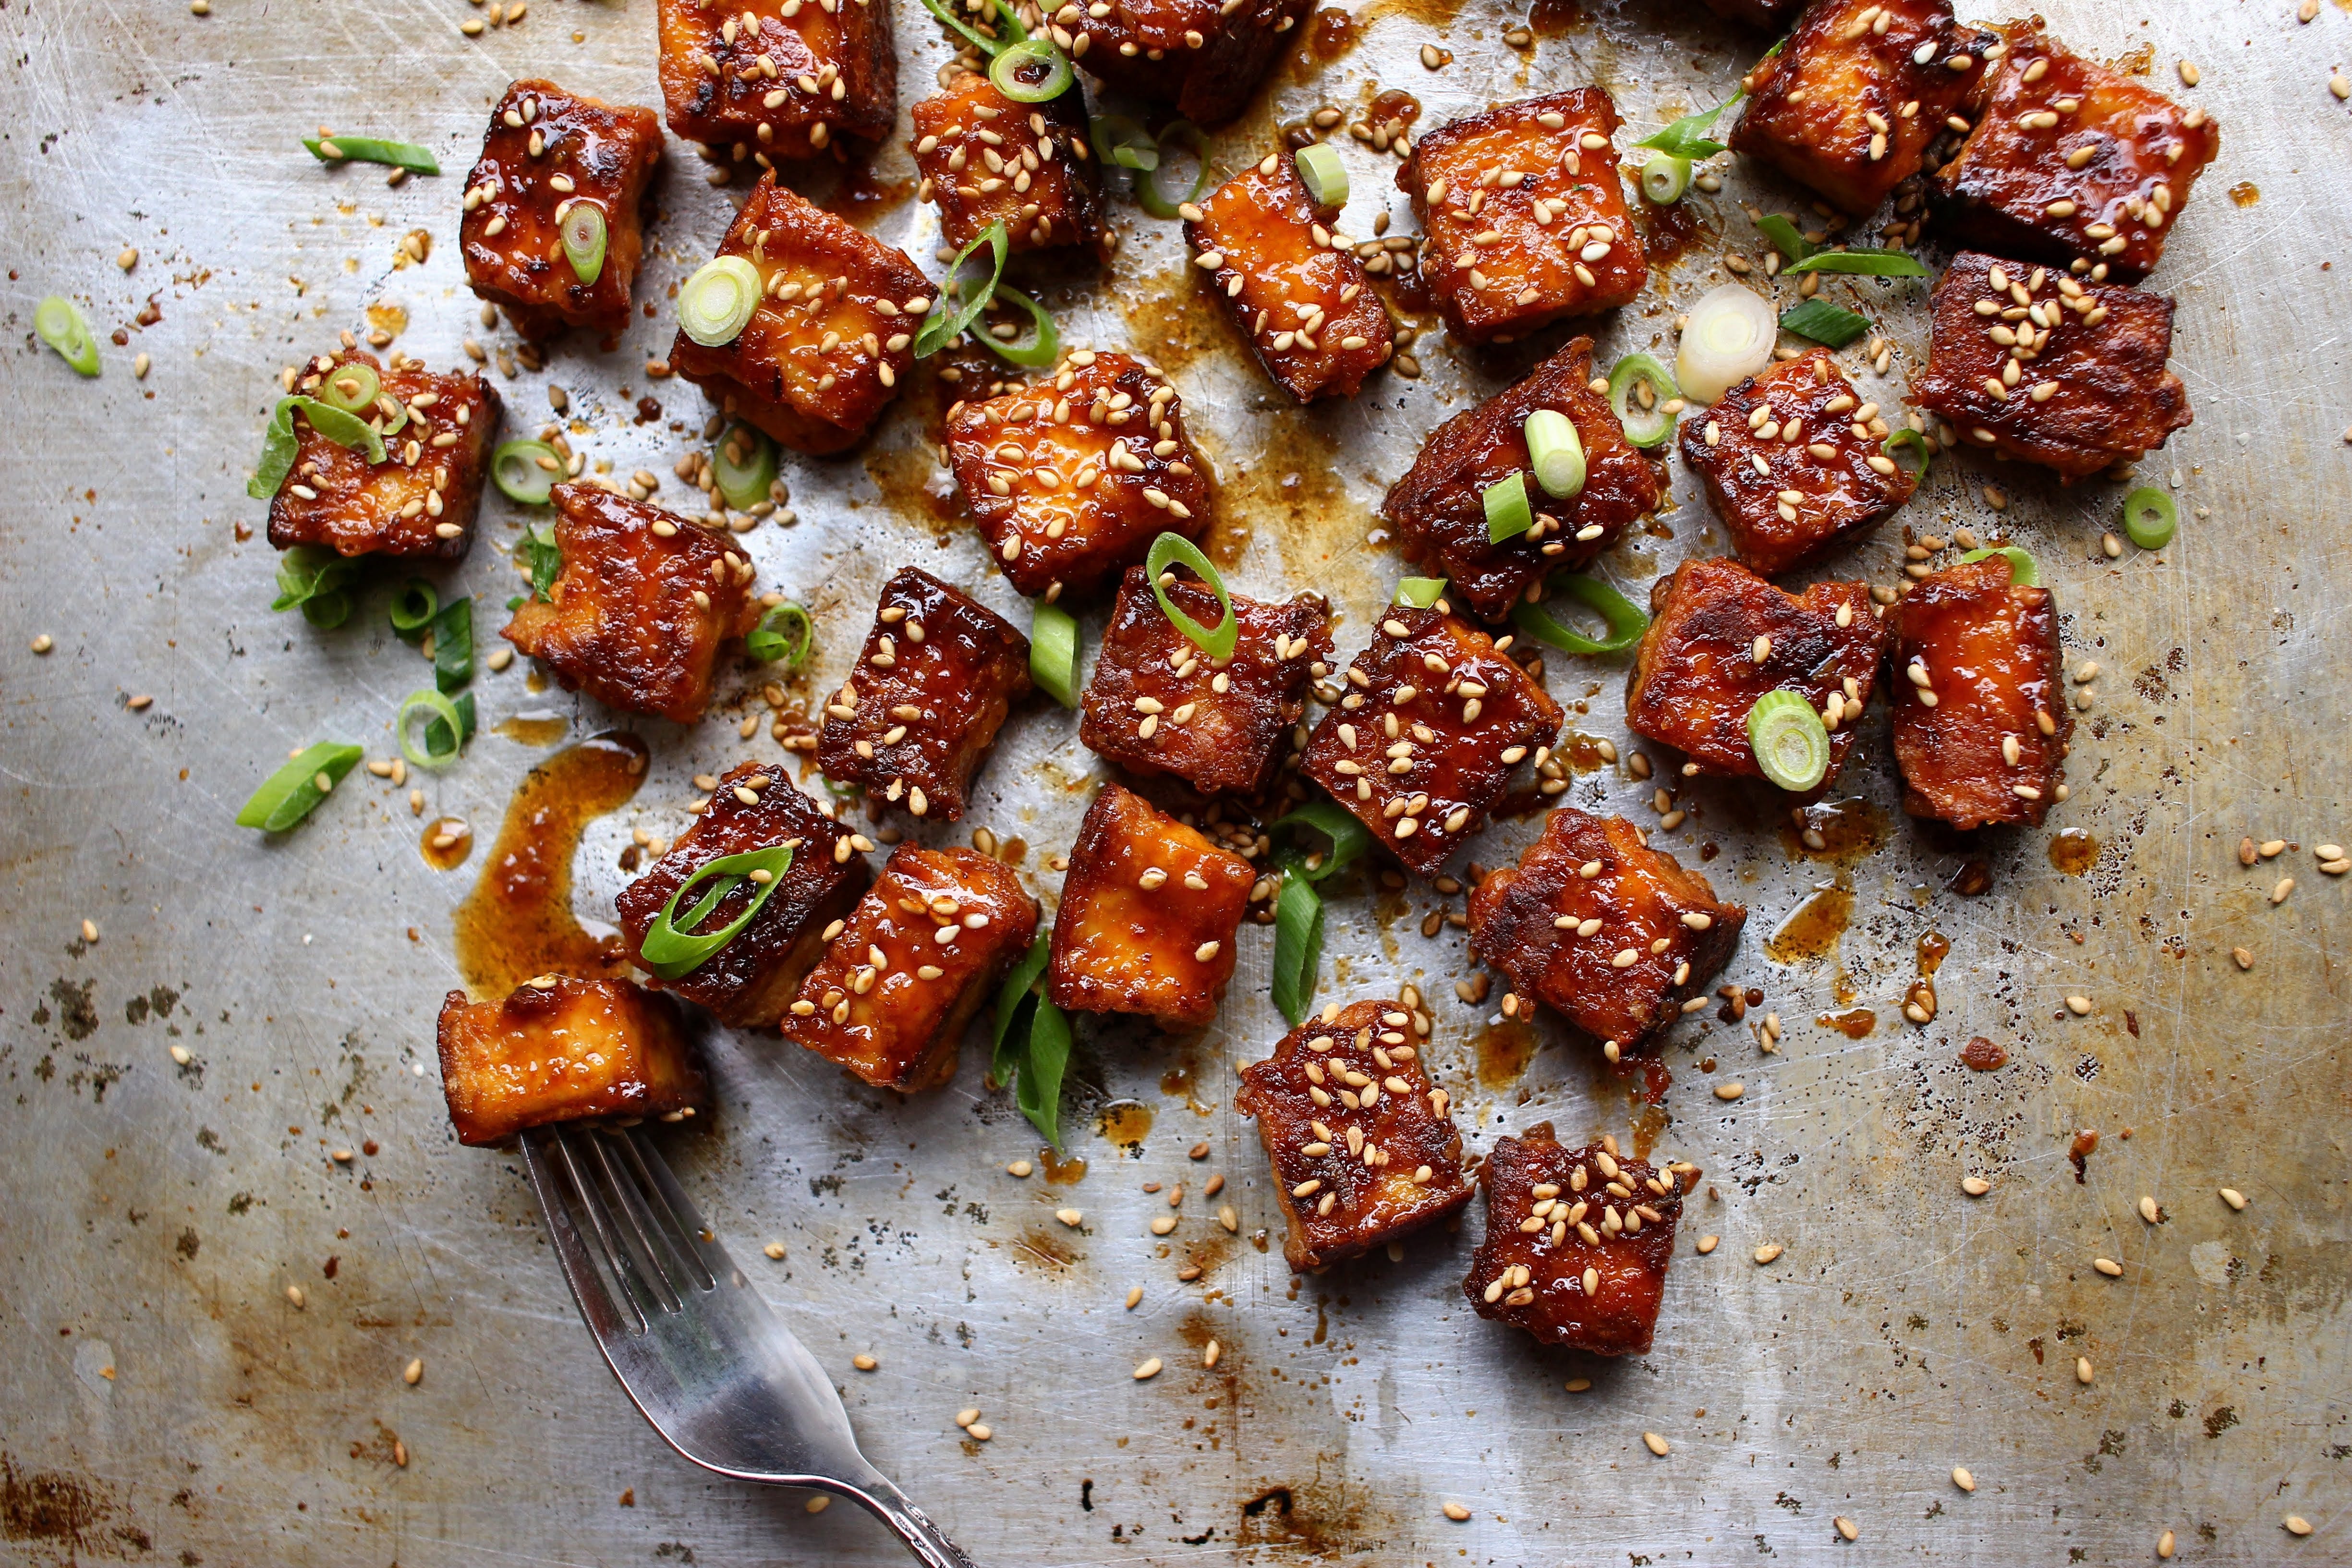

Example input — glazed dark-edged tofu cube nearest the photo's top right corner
[1936,19,2220,282]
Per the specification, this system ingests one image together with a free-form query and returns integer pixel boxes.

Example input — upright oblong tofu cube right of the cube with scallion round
[1889,555,2074,827]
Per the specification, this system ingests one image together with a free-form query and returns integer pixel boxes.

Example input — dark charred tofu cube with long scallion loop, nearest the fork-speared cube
[618,762,870,1030]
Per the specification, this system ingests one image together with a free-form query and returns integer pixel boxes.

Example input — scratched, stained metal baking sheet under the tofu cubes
[0,0,2352,1566]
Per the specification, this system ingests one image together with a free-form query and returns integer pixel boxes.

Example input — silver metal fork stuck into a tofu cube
[522,1129,974,1568]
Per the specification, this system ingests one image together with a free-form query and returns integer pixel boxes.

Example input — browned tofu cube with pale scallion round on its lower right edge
[1625,562,1886,785]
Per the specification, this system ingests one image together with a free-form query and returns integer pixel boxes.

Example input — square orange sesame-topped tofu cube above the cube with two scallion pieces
[1397,87,1649,343]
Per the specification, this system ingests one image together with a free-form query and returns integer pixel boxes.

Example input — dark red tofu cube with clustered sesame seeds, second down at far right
[1910,252,2194,484]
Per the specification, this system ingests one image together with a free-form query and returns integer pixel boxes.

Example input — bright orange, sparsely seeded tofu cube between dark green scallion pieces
[1047,783,1258,1030]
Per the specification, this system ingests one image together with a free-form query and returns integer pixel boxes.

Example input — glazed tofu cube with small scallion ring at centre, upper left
[459,82,661,339]
